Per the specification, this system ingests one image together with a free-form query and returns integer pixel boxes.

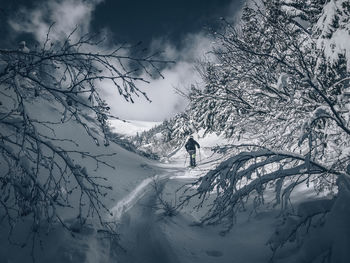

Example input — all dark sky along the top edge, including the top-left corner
[0,0,244,48]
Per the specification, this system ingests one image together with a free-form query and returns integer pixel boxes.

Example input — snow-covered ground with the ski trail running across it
[0,118,350,263]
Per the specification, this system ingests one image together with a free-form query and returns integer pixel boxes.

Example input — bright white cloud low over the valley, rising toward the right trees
[104,33,212,121]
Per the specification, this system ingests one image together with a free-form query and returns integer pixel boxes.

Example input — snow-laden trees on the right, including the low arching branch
[184,0,350,262]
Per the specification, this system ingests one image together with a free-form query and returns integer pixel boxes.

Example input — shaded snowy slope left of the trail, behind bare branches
[0,101,163,263]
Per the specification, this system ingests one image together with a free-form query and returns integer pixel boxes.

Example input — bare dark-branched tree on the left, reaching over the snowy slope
[0,28,168,258]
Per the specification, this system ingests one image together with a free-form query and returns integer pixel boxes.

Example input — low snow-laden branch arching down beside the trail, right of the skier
[183,149,342,228]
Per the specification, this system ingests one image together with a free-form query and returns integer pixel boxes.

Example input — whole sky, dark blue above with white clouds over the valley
[0,0,244,121]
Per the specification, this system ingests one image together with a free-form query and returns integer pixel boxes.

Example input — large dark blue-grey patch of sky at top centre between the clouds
[92,0,242,45]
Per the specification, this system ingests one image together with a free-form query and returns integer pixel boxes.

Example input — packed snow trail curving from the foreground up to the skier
[111,148,221,263]
